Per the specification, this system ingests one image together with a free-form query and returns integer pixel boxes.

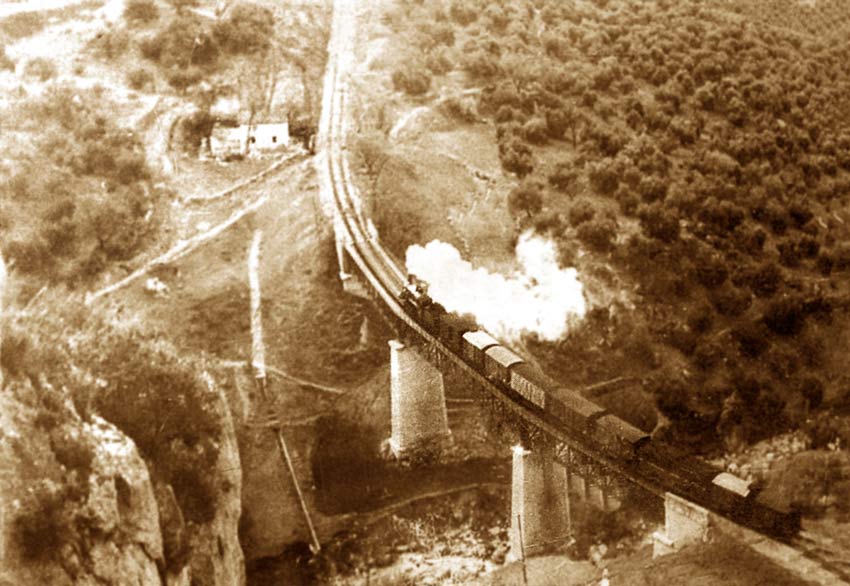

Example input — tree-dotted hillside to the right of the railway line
[348,0,850,510]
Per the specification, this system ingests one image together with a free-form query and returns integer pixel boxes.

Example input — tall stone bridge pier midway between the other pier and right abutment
[508,446,571,560]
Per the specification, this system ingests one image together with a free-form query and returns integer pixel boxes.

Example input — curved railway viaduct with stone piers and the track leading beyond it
[315,2,710,559]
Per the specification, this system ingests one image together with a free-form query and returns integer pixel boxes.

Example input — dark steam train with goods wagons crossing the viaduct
[398,275,801,540]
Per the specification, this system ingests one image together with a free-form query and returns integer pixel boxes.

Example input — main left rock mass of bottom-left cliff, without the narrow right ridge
[0,385,163,586]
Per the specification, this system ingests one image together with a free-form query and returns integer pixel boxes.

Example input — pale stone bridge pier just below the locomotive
[389,340,451,458]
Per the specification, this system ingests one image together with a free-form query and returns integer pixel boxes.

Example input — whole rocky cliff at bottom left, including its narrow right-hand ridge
[0,370,245,586]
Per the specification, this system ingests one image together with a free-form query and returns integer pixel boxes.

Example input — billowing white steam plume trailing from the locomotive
[406,231,586,342]
